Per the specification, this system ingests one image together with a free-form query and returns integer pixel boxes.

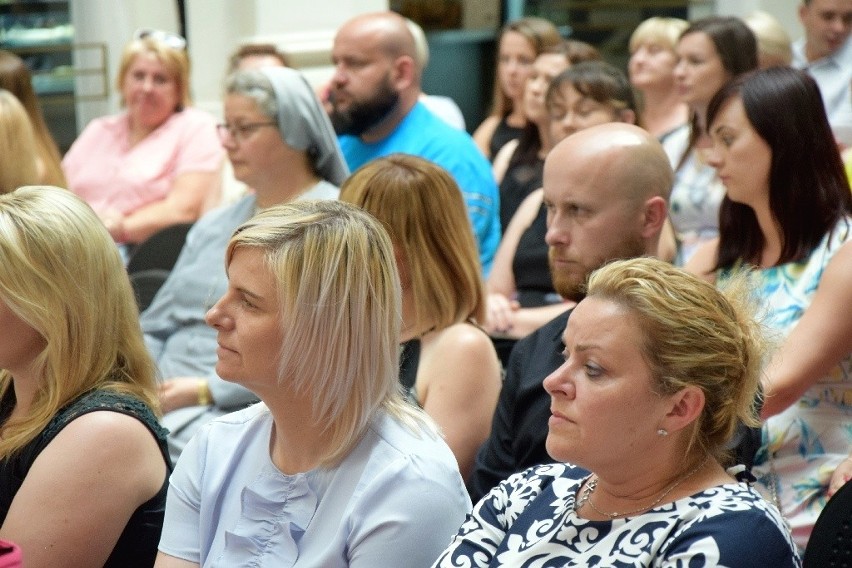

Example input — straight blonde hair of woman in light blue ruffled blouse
[226,200,432,467]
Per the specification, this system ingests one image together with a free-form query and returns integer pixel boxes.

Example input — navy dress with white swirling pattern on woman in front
[434,464,801,568]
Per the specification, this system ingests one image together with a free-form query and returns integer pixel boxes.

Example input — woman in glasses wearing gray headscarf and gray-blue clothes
[141,67,349,460]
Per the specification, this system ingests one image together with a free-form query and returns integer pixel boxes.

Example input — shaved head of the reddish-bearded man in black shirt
[544,122,673,300]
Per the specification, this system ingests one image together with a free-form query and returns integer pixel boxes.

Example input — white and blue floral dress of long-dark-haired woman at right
[718,218,852,548]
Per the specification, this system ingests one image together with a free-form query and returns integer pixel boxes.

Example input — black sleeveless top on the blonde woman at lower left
[0,388,172,568]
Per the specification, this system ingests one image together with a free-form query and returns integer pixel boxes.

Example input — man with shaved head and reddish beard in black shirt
[469,123,673,496]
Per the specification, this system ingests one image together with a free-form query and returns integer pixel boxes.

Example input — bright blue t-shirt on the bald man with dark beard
[338,103,500,276]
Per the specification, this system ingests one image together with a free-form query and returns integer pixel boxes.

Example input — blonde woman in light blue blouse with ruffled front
[156,201,469,568]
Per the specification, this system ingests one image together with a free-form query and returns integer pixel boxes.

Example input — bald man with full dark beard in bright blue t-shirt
[329,12,500,275]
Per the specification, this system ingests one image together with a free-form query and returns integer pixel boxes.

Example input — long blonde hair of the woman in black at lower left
[0,186,159,457]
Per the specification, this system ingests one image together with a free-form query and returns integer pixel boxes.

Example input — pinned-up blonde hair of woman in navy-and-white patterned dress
[586,258,764,461]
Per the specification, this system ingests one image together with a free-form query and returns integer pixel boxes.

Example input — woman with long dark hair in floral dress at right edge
[689,67,852,547]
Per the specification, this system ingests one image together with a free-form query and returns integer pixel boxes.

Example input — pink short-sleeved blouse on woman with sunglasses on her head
[62,108,224,215]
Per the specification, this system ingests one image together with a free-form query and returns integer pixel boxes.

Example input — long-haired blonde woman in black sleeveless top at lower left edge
[0,187,171,568]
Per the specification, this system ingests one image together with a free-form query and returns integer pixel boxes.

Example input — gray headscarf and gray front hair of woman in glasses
[227,67,349,187]
